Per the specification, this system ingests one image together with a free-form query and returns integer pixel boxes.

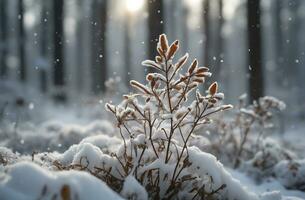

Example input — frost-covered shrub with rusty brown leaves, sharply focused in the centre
[105,35,241,199]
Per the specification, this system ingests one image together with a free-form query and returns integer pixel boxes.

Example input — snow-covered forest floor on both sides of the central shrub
[0,77,305,200]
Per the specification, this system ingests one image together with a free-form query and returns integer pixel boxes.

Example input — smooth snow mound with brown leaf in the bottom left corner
[0,162,121,200]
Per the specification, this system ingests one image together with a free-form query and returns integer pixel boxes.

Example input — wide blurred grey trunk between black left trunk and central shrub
[92,0,107,94]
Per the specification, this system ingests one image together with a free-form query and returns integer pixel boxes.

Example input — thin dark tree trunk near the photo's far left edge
[18,0,27,81]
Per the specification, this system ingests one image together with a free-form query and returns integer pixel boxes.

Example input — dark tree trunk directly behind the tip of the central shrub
[148,0,164,72]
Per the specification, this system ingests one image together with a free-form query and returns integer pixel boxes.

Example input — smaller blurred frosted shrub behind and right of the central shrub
[211,95,285,168]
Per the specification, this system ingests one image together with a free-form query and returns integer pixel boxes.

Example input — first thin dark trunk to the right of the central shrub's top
[203,0,211,66]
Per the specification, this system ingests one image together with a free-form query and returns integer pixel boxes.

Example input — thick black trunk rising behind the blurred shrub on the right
[247,0,264,101]
